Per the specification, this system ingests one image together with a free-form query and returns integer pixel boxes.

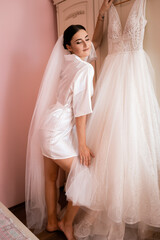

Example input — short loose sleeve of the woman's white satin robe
[73,64,94,117]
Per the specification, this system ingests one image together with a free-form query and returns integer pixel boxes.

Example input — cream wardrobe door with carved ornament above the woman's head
[57,0,94,38]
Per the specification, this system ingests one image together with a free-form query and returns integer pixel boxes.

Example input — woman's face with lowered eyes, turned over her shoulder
[67,29,91,60]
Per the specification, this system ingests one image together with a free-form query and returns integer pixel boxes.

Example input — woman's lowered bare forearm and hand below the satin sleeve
[75,115,94,166]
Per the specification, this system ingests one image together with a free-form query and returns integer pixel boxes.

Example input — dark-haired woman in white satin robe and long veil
[26,0,112,240]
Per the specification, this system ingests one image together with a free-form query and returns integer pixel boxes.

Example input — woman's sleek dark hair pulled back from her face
[63,25,86,49]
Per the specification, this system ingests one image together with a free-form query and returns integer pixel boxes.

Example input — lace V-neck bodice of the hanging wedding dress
[108,0,147,54]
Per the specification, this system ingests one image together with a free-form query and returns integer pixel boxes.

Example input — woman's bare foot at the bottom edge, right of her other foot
[58,219,76,240]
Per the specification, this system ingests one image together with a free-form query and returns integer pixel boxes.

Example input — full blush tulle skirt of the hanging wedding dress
[66,50,160,240]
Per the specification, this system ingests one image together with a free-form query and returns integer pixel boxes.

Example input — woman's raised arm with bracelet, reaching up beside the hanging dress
[92,0,114,49]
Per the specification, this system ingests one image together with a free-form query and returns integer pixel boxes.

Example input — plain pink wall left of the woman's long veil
[0,0,57,207]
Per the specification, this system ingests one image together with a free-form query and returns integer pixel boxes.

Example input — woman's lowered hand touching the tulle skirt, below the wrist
[79,145,94,167]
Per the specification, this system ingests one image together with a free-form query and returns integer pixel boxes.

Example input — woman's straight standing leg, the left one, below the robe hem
[44,157,59,231]
